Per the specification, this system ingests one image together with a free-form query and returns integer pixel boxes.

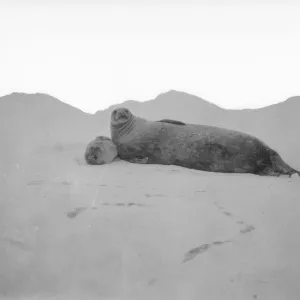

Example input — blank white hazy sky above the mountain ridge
[0,0,300,112]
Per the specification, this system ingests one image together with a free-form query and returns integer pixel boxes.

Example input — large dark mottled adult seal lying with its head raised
[110,108,300,176]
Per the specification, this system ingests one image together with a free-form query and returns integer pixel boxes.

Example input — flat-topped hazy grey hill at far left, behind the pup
[0,93,97,144]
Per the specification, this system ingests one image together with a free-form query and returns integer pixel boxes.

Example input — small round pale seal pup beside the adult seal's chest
[84,136,118,165]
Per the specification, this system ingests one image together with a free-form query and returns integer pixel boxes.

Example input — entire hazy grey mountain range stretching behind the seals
[0,90,300,166]
